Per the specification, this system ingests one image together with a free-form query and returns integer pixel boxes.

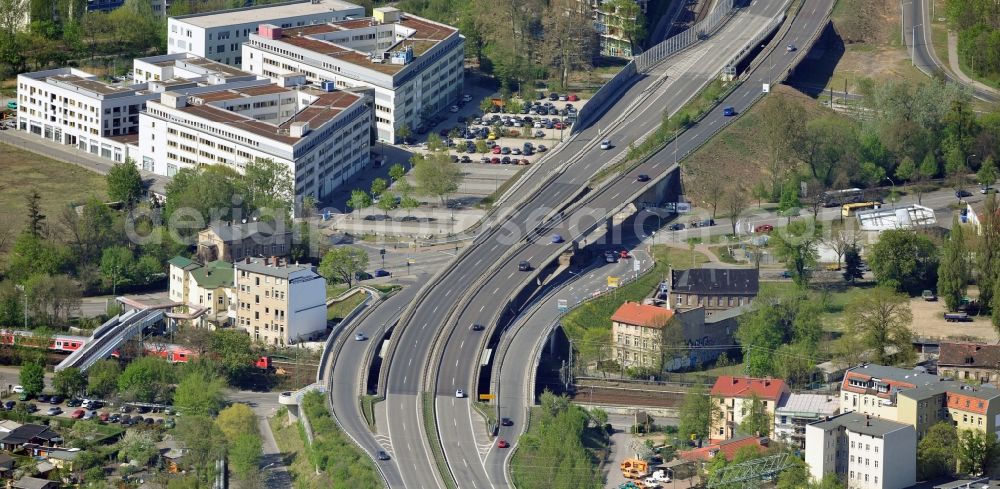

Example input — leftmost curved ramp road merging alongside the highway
[328,274,429,487]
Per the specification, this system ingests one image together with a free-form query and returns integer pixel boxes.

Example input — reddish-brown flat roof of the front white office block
[165,85,361,145]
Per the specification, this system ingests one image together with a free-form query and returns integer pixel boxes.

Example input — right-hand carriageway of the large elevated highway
[430,0,833,488]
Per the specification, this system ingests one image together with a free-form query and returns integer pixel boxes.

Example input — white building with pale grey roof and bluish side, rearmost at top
[167,0,365,67]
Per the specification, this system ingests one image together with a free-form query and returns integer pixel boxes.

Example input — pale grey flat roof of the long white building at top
[172,0,364,29]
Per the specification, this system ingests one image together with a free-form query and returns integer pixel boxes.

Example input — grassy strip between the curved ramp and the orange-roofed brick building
[561,245,709,344]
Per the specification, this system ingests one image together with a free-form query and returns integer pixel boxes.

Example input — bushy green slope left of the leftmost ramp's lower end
[296,391,382,489]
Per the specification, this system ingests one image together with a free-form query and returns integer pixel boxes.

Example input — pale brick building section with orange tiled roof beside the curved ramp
[611,302,674,368]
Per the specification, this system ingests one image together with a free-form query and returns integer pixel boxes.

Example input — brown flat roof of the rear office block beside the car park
[270,12,458,75]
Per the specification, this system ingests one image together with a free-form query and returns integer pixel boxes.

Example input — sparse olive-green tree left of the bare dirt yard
[846,287,913,365]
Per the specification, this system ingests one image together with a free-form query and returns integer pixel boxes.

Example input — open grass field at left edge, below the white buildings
[0,144,108,260]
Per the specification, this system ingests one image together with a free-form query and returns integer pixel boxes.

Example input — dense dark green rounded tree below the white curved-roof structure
[868,229,938,295]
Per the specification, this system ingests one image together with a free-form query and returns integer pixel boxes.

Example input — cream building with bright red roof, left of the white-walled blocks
[709,375,791,440]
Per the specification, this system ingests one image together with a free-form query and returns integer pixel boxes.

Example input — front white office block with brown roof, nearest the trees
[139,75,371,200]
